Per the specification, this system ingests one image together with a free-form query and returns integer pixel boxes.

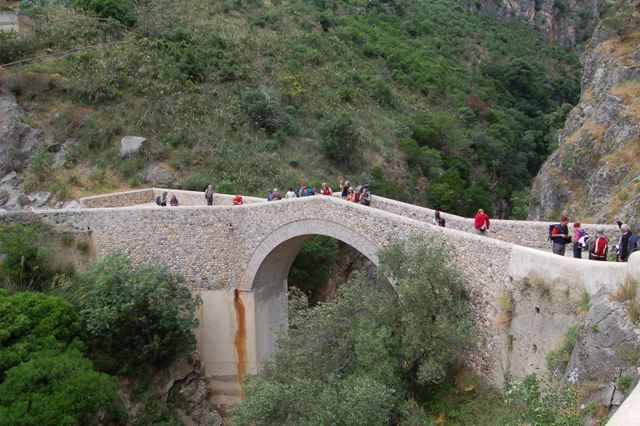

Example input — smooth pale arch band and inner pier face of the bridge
[237,219,379,373]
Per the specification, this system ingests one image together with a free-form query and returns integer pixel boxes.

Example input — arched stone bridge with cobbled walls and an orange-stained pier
[0,189,640,420]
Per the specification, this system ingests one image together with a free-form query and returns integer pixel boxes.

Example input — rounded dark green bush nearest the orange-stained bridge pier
[77,254,198,372]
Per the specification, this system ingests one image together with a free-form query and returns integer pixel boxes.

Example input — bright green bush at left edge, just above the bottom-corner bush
[0,292,81,378]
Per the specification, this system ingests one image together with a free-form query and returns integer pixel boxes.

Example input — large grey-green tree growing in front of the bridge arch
[233,240,471,425]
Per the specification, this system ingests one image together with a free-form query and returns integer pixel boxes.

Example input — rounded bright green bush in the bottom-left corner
[0,350,123,426]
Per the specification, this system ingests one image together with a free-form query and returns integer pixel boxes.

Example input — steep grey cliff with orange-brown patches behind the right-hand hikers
[529,0,640,227]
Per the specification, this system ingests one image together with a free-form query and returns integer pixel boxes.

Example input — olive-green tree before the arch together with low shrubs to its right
[233,240,582,426]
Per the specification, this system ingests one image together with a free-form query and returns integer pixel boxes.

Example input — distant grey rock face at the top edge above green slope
[464,0,598,47]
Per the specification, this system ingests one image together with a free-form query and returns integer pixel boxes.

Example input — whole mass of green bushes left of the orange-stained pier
[0,225,198,426]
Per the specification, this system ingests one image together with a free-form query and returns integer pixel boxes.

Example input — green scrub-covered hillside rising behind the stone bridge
[0,0,578,216]
